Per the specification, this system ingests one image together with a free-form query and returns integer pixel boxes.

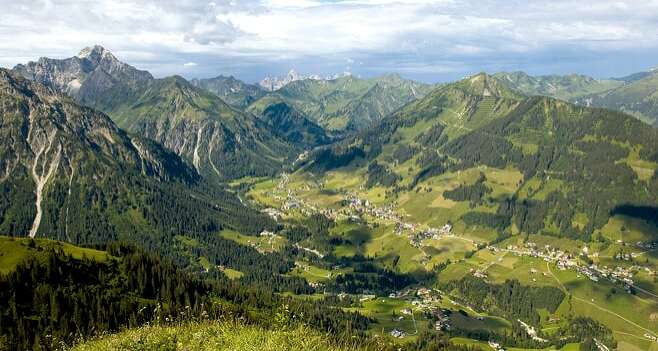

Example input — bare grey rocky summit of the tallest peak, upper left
[14,45,153,106]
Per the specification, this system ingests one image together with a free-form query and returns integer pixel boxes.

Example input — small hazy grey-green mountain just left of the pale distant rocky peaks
[190,76,266,109]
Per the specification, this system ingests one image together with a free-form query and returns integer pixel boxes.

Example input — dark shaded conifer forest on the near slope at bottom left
[0,238,369,350]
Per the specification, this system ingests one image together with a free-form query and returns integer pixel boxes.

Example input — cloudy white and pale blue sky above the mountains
[0,0,658,82]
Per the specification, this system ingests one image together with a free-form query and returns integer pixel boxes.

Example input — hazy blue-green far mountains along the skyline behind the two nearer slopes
[9,46,658,160]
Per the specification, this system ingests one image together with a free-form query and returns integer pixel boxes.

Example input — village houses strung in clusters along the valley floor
[241,174,658,350]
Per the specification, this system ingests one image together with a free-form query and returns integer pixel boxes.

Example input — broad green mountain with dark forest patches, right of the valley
[306,74,658,240]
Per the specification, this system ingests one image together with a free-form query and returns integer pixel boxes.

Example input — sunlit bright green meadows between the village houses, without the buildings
[241,158,658,350]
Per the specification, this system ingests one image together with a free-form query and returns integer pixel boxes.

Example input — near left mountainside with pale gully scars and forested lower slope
[0,69,270,248]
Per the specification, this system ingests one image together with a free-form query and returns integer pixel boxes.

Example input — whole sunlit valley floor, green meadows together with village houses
[234,167,658,351]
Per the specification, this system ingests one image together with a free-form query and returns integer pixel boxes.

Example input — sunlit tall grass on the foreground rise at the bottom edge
[72,322,366,351]
